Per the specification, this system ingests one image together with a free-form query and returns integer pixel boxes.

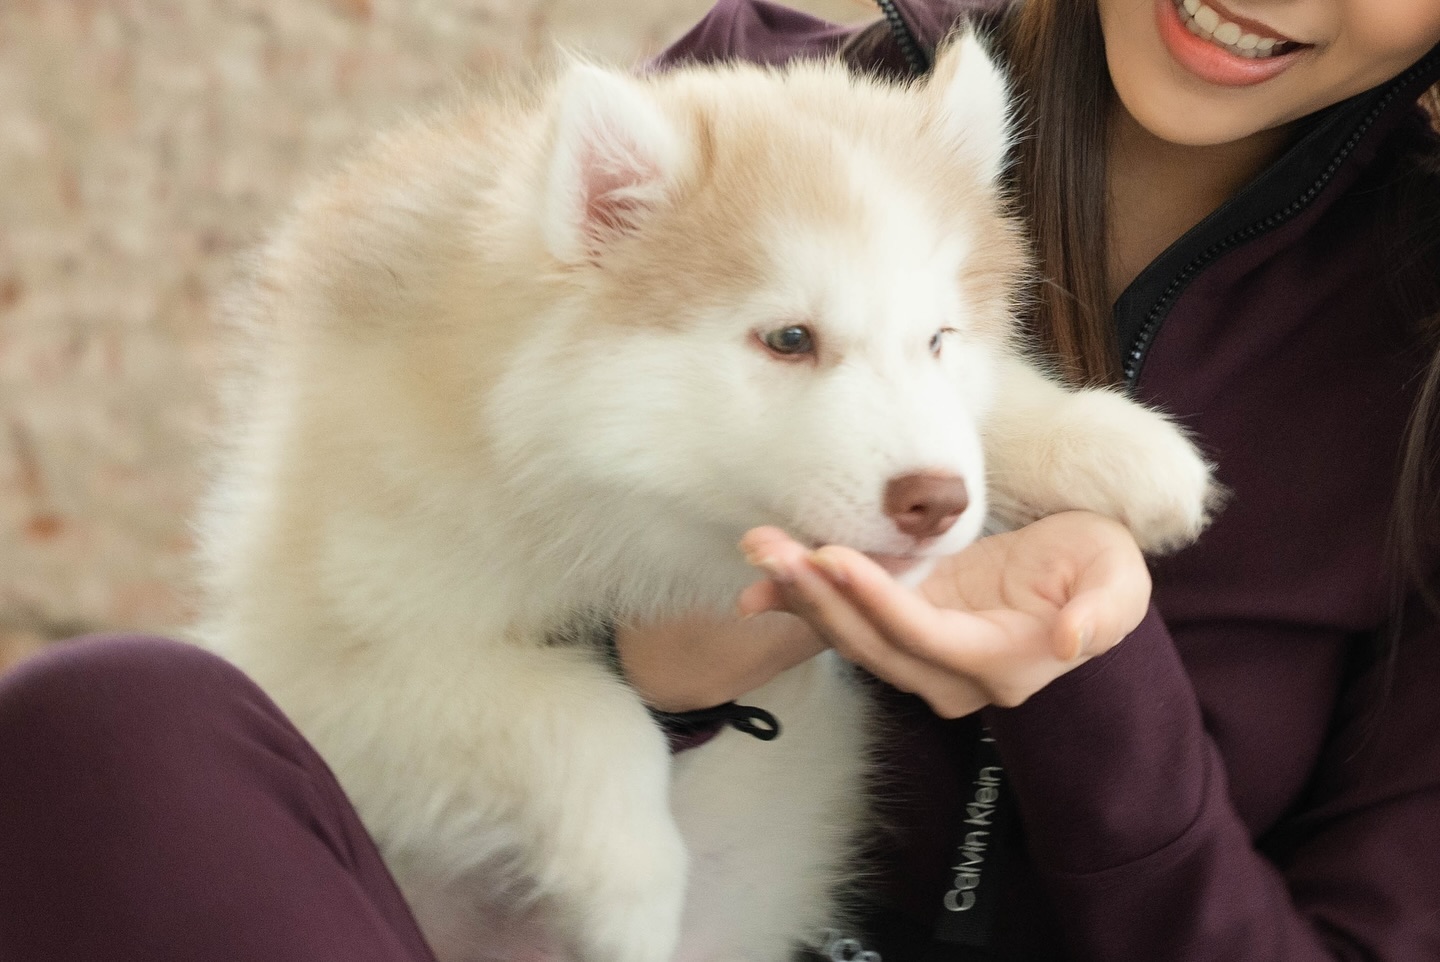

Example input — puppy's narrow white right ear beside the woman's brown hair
[929,30,1012,181]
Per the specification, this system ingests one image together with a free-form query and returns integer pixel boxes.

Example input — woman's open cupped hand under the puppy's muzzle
[740,511,1151,717]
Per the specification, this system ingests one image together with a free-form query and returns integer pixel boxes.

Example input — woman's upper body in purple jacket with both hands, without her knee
[619,0,1440,962]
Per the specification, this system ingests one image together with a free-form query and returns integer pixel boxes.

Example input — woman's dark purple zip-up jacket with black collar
[662,0,1440,962]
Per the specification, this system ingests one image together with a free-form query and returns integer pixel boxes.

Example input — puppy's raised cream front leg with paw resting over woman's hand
[984,357,1217,553]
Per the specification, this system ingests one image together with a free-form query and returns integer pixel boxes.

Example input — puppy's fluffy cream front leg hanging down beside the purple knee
[365,645,688,962]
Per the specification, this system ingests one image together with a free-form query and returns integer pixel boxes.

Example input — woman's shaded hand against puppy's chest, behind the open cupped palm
[615,612,825,711]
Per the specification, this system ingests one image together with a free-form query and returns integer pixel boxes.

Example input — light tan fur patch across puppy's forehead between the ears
[567,65,1027,340]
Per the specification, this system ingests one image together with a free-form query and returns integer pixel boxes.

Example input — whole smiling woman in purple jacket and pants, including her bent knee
[8,0,1440,962]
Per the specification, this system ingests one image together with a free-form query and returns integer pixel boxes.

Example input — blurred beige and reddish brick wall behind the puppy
[0,0,876,670]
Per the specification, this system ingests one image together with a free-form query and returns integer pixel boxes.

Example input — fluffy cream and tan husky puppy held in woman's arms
[197,37,1210,962]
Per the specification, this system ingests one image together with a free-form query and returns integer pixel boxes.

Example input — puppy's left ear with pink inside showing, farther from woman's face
[543,63,687,265]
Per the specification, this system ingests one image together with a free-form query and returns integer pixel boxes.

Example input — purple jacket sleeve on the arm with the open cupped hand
[988,609,1440,962]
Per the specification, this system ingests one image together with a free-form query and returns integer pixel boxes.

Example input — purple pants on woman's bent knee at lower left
[0,638,435,962]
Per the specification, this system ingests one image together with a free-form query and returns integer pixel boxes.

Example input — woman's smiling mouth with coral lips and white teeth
[1155,0,1310,86]
